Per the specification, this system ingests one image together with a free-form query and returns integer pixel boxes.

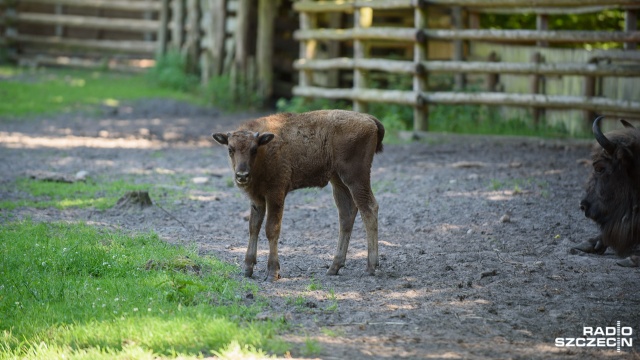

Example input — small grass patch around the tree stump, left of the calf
[0,178,151,210]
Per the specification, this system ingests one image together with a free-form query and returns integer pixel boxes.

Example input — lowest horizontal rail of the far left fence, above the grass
[9,34,156,54]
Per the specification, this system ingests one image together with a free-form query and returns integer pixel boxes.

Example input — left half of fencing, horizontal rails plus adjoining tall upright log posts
[0,0,297,98]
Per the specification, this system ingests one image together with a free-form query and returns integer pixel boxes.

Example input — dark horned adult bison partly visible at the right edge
[576,116,640,267]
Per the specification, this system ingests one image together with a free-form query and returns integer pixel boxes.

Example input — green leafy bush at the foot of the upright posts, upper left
[147,51,199,92]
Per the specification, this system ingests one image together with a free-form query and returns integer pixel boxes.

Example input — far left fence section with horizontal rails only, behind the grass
[0,0,167,69]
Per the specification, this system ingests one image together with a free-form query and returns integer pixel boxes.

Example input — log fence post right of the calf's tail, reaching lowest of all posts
[413,4,429,131]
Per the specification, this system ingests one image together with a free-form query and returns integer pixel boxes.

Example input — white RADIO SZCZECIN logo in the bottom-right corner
[555,321,633,352]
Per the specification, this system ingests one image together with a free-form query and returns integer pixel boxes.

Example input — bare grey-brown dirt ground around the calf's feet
[0,100,640,359]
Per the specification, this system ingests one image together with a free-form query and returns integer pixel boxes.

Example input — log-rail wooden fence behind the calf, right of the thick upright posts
[293,0,640,130]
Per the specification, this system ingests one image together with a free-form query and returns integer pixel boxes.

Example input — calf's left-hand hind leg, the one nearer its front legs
[327,176,358,275]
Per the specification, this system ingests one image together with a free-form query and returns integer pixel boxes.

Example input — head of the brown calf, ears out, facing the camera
[212,131,275,186]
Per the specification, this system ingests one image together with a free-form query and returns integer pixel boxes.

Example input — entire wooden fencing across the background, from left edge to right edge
[0,0,640,130]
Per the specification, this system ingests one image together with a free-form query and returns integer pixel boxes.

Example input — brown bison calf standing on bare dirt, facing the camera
[213,110,384,281]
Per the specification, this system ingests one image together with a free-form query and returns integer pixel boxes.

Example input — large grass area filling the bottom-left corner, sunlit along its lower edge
[0,221,288,359]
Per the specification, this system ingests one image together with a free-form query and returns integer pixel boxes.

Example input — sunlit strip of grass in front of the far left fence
[0,67,199,118]
